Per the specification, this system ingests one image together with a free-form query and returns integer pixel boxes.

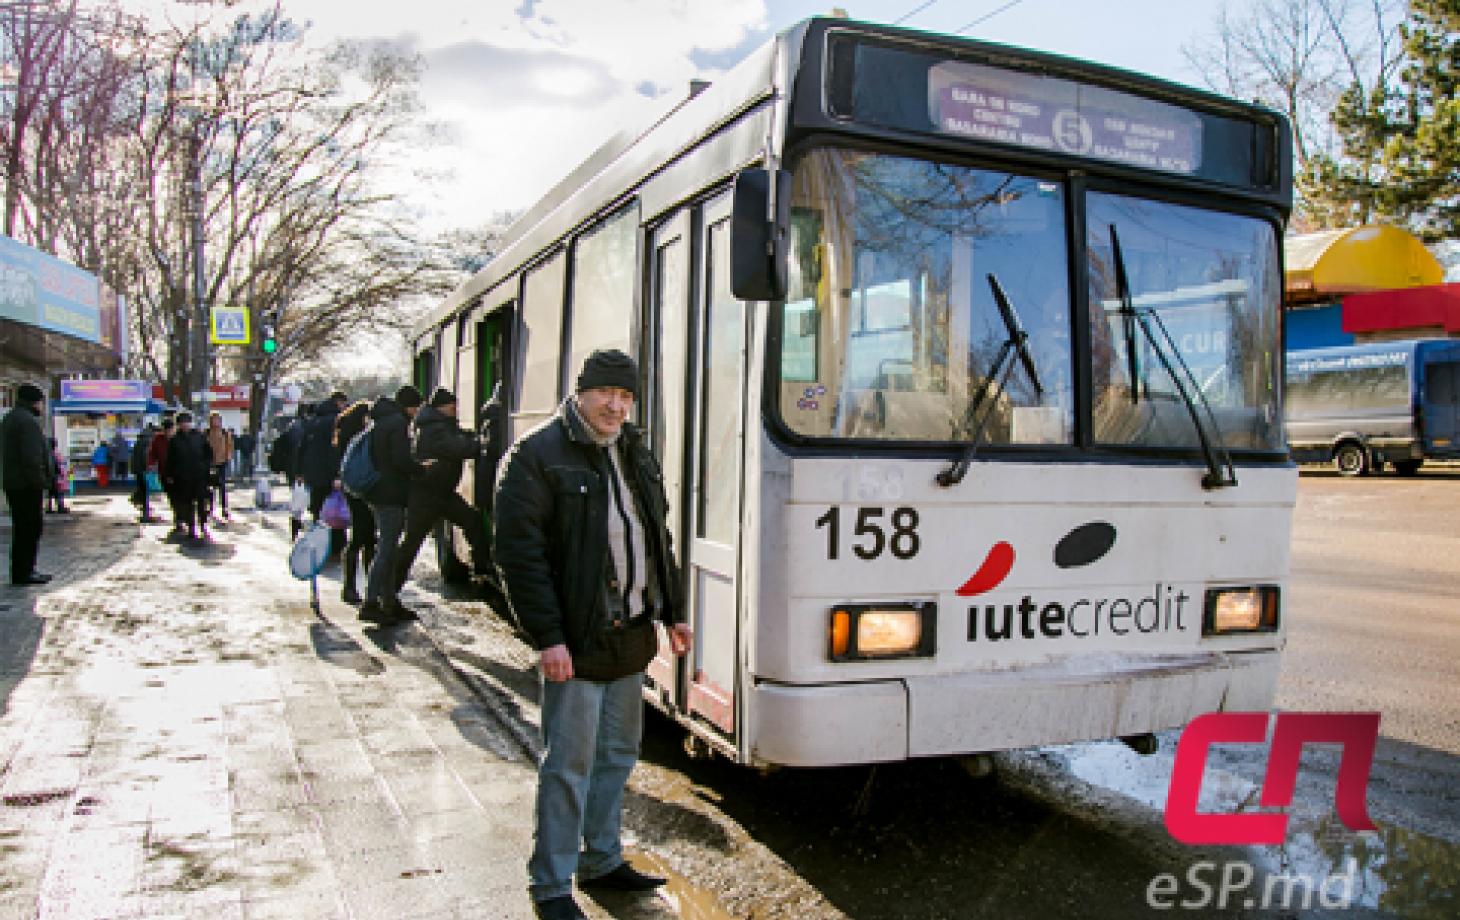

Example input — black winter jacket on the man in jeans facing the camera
[492,397,685,656]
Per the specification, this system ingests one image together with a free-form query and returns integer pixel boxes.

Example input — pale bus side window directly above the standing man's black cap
[568,206,638,394]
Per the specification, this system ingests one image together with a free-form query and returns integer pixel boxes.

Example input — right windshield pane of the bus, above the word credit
[1086,193,1283,450]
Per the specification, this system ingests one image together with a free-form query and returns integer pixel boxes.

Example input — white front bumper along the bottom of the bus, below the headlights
[750,650,1280,767]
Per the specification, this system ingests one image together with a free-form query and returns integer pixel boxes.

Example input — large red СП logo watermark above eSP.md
[1167,713,1378,846]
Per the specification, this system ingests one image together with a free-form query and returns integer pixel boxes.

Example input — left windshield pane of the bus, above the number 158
[780,150,1075,444]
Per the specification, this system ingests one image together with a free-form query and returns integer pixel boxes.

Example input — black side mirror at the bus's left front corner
[730,168,791,301]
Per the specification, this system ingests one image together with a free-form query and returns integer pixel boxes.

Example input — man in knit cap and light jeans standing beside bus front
[492,350,692,920]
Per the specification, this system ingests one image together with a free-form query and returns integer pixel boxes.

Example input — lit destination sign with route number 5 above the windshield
[929,61,1202,174]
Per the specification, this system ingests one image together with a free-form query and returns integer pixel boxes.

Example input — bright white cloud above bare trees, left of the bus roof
[133,0,767,228]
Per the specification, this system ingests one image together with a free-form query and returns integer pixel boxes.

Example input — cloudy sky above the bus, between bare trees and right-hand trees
[205,0,1242,228]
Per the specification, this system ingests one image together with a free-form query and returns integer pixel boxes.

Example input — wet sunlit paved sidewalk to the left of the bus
[0,497,533,920]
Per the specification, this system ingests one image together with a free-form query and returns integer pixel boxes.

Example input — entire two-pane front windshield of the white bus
[780,149,1283,451]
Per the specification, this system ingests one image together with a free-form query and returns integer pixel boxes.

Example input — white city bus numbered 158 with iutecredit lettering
[415,19,1296,767]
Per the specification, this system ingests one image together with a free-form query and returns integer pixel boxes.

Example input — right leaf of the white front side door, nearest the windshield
[685,196,748,736]
